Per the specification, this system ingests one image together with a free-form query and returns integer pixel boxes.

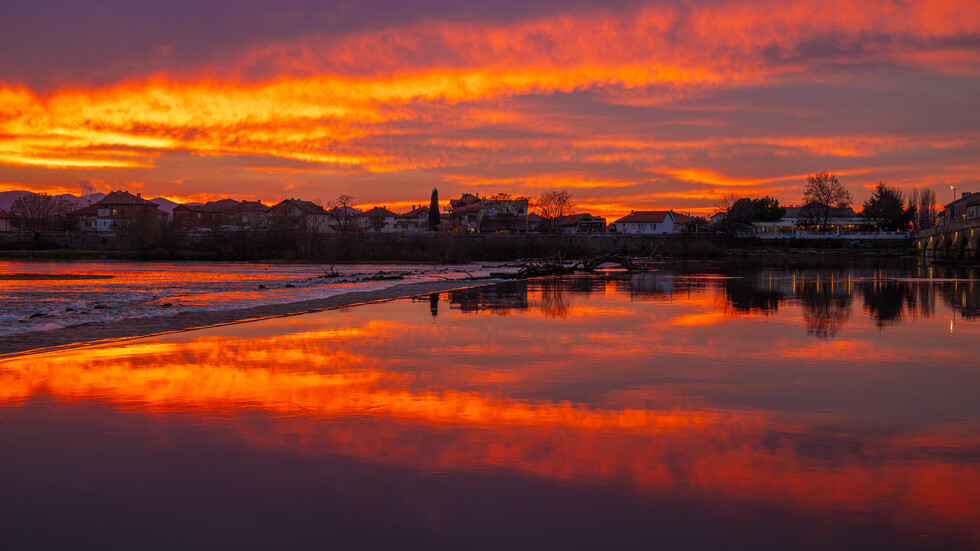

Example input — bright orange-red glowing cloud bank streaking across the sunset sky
[0,0,980,207]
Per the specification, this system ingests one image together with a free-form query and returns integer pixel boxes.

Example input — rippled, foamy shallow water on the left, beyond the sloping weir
[0,261,507,335]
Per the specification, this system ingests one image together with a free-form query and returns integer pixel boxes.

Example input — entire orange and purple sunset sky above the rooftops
[0,0,980,218]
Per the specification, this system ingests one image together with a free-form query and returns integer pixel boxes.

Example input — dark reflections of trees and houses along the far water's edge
[449,268,980,339]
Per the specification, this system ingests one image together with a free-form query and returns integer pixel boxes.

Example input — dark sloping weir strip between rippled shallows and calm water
[0,279,502,358]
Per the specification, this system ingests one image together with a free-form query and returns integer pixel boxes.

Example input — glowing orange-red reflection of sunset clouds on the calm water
[0,270,980,548]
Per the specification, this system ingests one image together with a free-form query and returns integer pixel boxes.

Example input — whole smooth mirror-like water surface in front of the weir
[0,265,980,550]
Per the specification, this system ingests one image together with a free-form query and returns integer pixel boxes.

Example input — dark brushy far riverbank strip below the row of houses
[0,232,916,264]
